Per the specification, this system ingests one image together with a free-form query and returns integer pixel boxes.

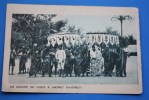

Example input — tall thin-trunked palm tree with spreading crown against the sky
[111,15,133,36]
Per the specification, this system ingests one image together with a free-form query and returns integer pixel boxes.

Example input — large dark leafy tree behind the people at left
[12,14,67,55]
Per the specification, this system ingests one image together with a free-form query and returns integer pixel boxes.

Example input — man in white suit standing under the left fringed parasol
[55,45,66,77]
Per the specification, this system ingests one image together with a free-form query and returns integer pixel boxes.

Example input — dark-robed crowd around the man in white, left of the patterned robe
[29,40,90,77]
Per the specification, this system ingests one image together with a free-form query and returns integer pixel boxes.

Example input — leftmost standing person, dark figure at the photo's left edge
[9,49,16,75]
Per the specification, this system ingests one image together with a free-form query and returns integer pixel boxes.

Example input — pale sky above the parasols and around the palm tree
[52,15,136,38]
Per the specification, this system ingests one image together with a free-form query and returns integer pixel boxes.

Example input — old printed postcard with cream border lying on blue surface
[2,4,142,94]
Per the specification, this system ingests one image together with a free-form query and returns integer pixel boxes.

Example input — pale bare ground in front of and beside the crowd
[9,56,138,84]
